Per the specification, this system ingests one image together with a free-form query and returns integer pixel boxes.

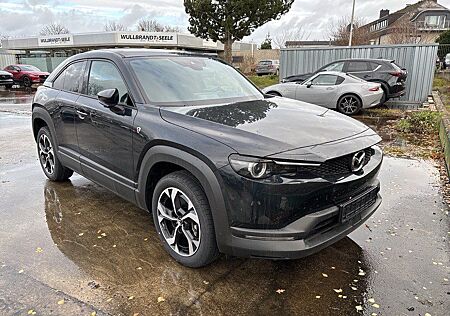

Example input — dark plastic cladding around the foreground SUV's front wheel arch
[136,145,230,251]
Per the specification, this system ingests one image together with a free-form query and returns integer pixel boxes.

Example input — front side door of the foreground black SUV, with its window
[76,60,137,195]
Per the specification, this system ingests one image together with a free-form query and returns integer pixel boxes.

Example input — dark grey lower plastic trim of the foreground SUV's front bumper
[232,190,382,259]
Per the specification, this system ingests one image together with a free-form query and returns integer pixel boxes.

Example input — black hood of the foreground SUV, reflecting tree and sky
[160,97,374,157]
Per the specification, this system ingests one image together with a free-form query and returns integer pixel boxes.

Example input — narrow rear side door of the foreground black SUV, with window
[48,60,87,172]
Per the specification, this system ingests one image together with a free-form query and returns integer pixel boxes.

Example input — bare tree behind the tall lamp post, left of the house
[329,17,370,46]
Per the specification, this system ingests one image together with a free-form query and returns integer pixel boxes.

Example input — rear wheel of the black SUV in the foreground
[37,127,73,182]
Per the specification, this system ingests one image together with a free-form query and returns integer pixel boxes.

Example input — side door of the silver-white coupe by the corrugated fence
[296,74,340,108]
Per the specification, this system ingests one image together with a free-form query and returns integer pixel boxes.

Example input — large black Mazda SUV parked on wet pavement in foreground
[32,49,382,267]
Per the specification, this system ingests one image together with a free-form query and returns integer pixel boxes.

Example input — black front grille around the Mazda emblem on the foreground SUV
[297,148,374,178]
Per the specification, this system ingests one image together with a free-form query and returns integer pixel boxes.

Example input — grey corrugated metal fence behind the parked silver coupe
[280,44,438,102]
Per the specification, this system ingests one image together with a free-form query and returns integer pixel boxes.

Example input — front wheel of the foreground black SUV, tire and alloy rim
[152,171,219,268]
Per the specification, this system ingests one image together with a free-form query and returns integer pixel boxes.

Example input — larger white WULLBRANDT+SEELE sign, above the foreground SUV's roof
[117,32,178,45]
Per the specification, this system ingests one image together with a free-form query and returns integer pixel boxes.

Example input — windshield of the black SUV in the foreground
[130,56,263,106]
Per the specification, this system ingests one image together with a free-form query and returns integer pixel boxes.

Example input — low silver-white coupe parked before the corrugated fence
[263,71,383,115]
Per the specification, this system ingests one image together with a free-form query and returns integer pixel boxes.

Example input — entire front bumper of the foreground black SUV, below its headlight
[218,145,383,259]
